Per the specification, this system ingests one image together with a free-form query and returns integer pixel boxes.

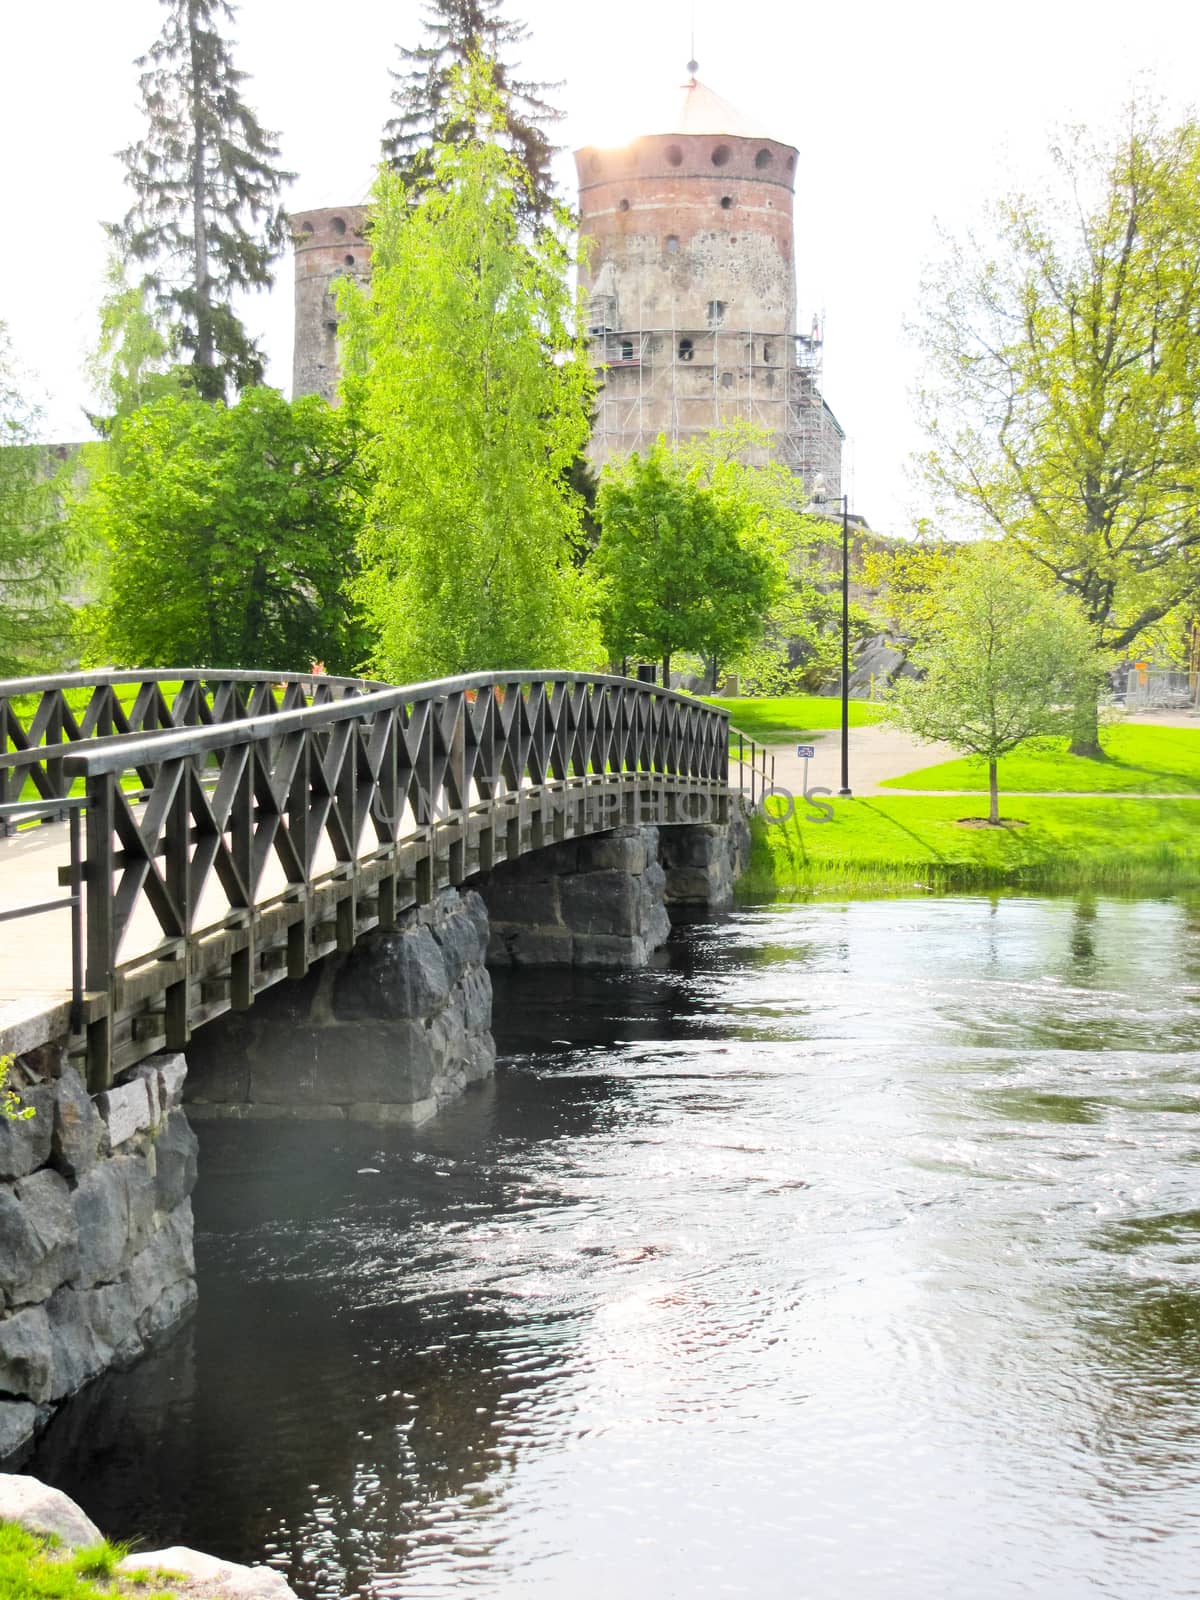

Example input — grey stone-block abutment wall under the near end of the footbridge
[0,1051,197,1458]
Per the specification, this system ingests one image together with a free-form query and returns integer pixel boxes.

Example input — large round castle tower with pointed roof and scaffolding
[574,62,845,494]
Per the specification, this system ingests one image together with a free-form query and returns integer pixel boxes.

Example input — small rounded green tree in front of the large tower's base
[595,438,784,682]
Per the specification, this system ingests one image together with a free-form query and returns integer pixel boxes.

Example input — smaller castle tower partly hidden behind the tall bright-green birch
[291,205,371,403]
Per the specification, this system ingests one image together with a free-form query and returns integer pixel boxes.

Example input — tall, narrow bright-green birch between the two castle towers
[339,69,598,683]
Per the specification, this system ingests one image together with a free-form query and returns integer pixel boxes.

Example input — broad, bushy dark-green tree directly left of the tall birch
[72,389,368,672]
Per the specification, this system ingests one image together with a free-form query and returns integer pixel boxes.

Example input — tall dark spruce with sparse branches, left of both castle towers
[114,0,293,400]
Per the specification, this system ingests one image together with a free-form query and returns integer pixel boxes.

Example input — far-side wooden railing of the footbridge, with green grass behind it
[0,667,382,818]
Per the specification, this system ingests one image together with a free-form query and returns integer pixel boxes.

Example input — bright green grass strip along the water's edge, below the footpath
[739,795,1200,898]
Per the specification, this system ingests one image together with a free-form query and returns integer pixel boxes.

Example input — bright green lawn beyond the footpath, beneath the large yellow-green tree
[883,723,1200,795]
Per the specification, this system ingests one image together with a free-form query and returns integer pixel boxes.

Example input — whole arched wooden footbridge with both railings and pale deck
[0,670,760,1091]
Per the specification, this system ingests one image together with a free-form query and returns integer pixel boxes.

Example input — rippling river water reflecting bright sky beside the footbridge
[29,898,1200,1600]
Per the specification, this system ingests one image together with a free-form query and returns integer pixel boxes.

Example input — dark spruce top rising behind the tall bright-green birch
[382,0,563,222]
